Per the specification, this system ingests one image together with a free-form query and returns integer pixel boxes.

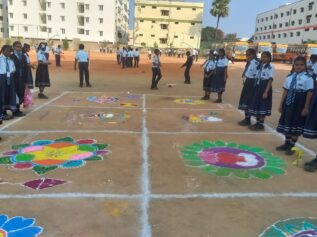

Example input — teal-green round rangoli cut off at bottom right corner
[259,218,317,237]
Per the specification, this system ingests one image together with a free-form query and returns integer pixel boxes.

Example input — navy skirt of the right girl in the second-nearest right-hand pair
[248,80,272,116]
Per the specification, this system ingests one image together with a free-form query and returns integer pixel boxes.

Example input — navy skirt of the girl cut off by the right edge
[303,83,317,139]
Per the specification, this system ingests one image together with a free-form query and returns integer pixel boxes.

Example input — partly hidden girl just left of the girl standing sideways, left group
[22,44,36,89]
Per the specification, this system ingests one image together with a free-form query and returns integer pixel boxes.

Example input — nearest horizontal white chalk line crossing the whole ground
[0,192,317,200]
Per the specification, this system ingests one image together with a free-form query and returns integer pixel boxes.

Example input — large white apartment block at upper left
[0,0,129,43]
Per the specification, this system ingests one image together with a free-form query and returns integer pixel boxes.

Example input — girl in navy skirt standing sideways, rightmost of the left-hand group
[35,43,51,99]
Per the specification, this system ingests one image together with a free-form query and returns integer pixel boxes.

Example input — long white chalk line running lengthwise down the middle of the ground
[141,95,152,237]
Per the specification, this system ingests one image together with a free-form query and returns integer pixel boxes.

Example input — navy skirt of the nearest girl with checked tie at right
[276,91,307,136]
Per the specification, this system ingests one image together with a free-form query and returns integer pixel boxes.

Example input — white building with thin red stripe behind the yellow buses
[254,0,317,44]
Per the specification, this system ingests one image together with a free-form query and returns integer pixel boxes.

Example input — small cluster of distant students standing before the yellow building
[117,47,140,69]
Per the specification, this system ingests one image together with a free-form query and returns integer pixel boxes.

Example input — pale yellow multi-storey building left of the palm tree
[133,0,204,48]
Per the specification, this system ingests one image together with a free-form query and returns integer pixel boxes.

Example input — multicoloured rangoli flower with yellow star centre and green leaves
[0,137,110,175]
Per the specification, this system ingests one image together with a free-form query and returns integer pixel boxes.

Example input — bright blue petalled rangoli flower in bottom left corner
[0,215,43,237]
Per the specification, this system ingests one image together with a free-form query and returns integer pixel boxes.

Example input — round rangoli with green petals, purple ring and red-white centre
[182,141,285,179]
